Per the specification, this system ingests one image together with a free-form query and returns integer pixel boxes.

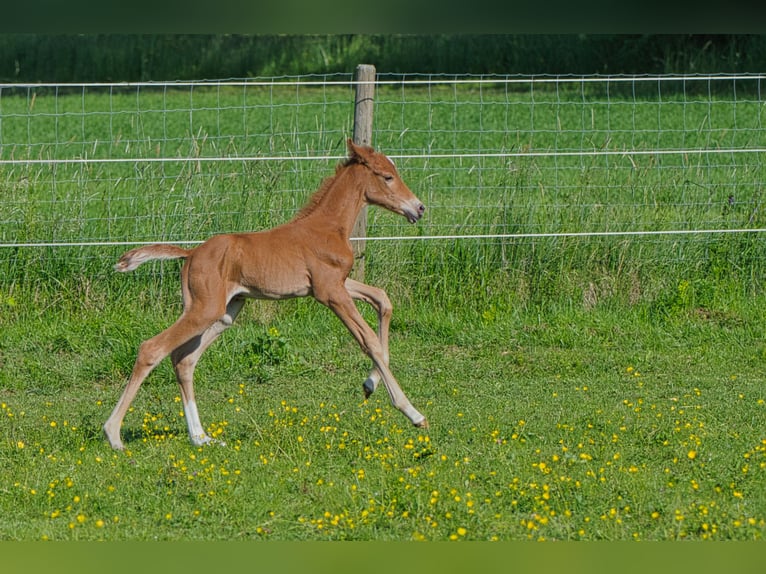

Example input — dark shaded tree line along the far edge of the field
[0,34,766,82]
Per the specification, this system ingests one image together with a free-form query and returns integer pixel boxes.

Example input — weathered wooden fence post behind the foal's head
[351,64,375,281]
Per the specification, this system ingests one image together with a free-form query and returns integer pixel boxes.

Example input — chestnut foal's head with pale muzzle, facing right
[348,139,426,223]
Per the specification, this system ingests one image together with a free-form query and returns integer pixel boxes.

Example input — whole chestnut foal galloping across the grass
[104,142,428,449]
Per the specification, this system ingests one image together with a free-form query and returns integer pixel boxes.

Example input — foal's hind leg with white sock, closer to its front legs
[171,298,245,446]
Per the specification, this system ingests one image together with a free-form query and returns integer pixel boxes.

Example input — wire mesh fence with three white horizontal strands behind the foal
[0,74,766,268]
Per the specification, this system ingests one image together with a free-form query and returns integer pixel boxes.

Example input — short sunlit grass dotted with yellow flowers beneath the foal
[0,294,766,541]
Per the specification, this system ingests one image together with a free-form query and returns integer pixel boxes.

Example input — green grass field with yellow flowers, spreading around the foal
[0,79,766,541]
